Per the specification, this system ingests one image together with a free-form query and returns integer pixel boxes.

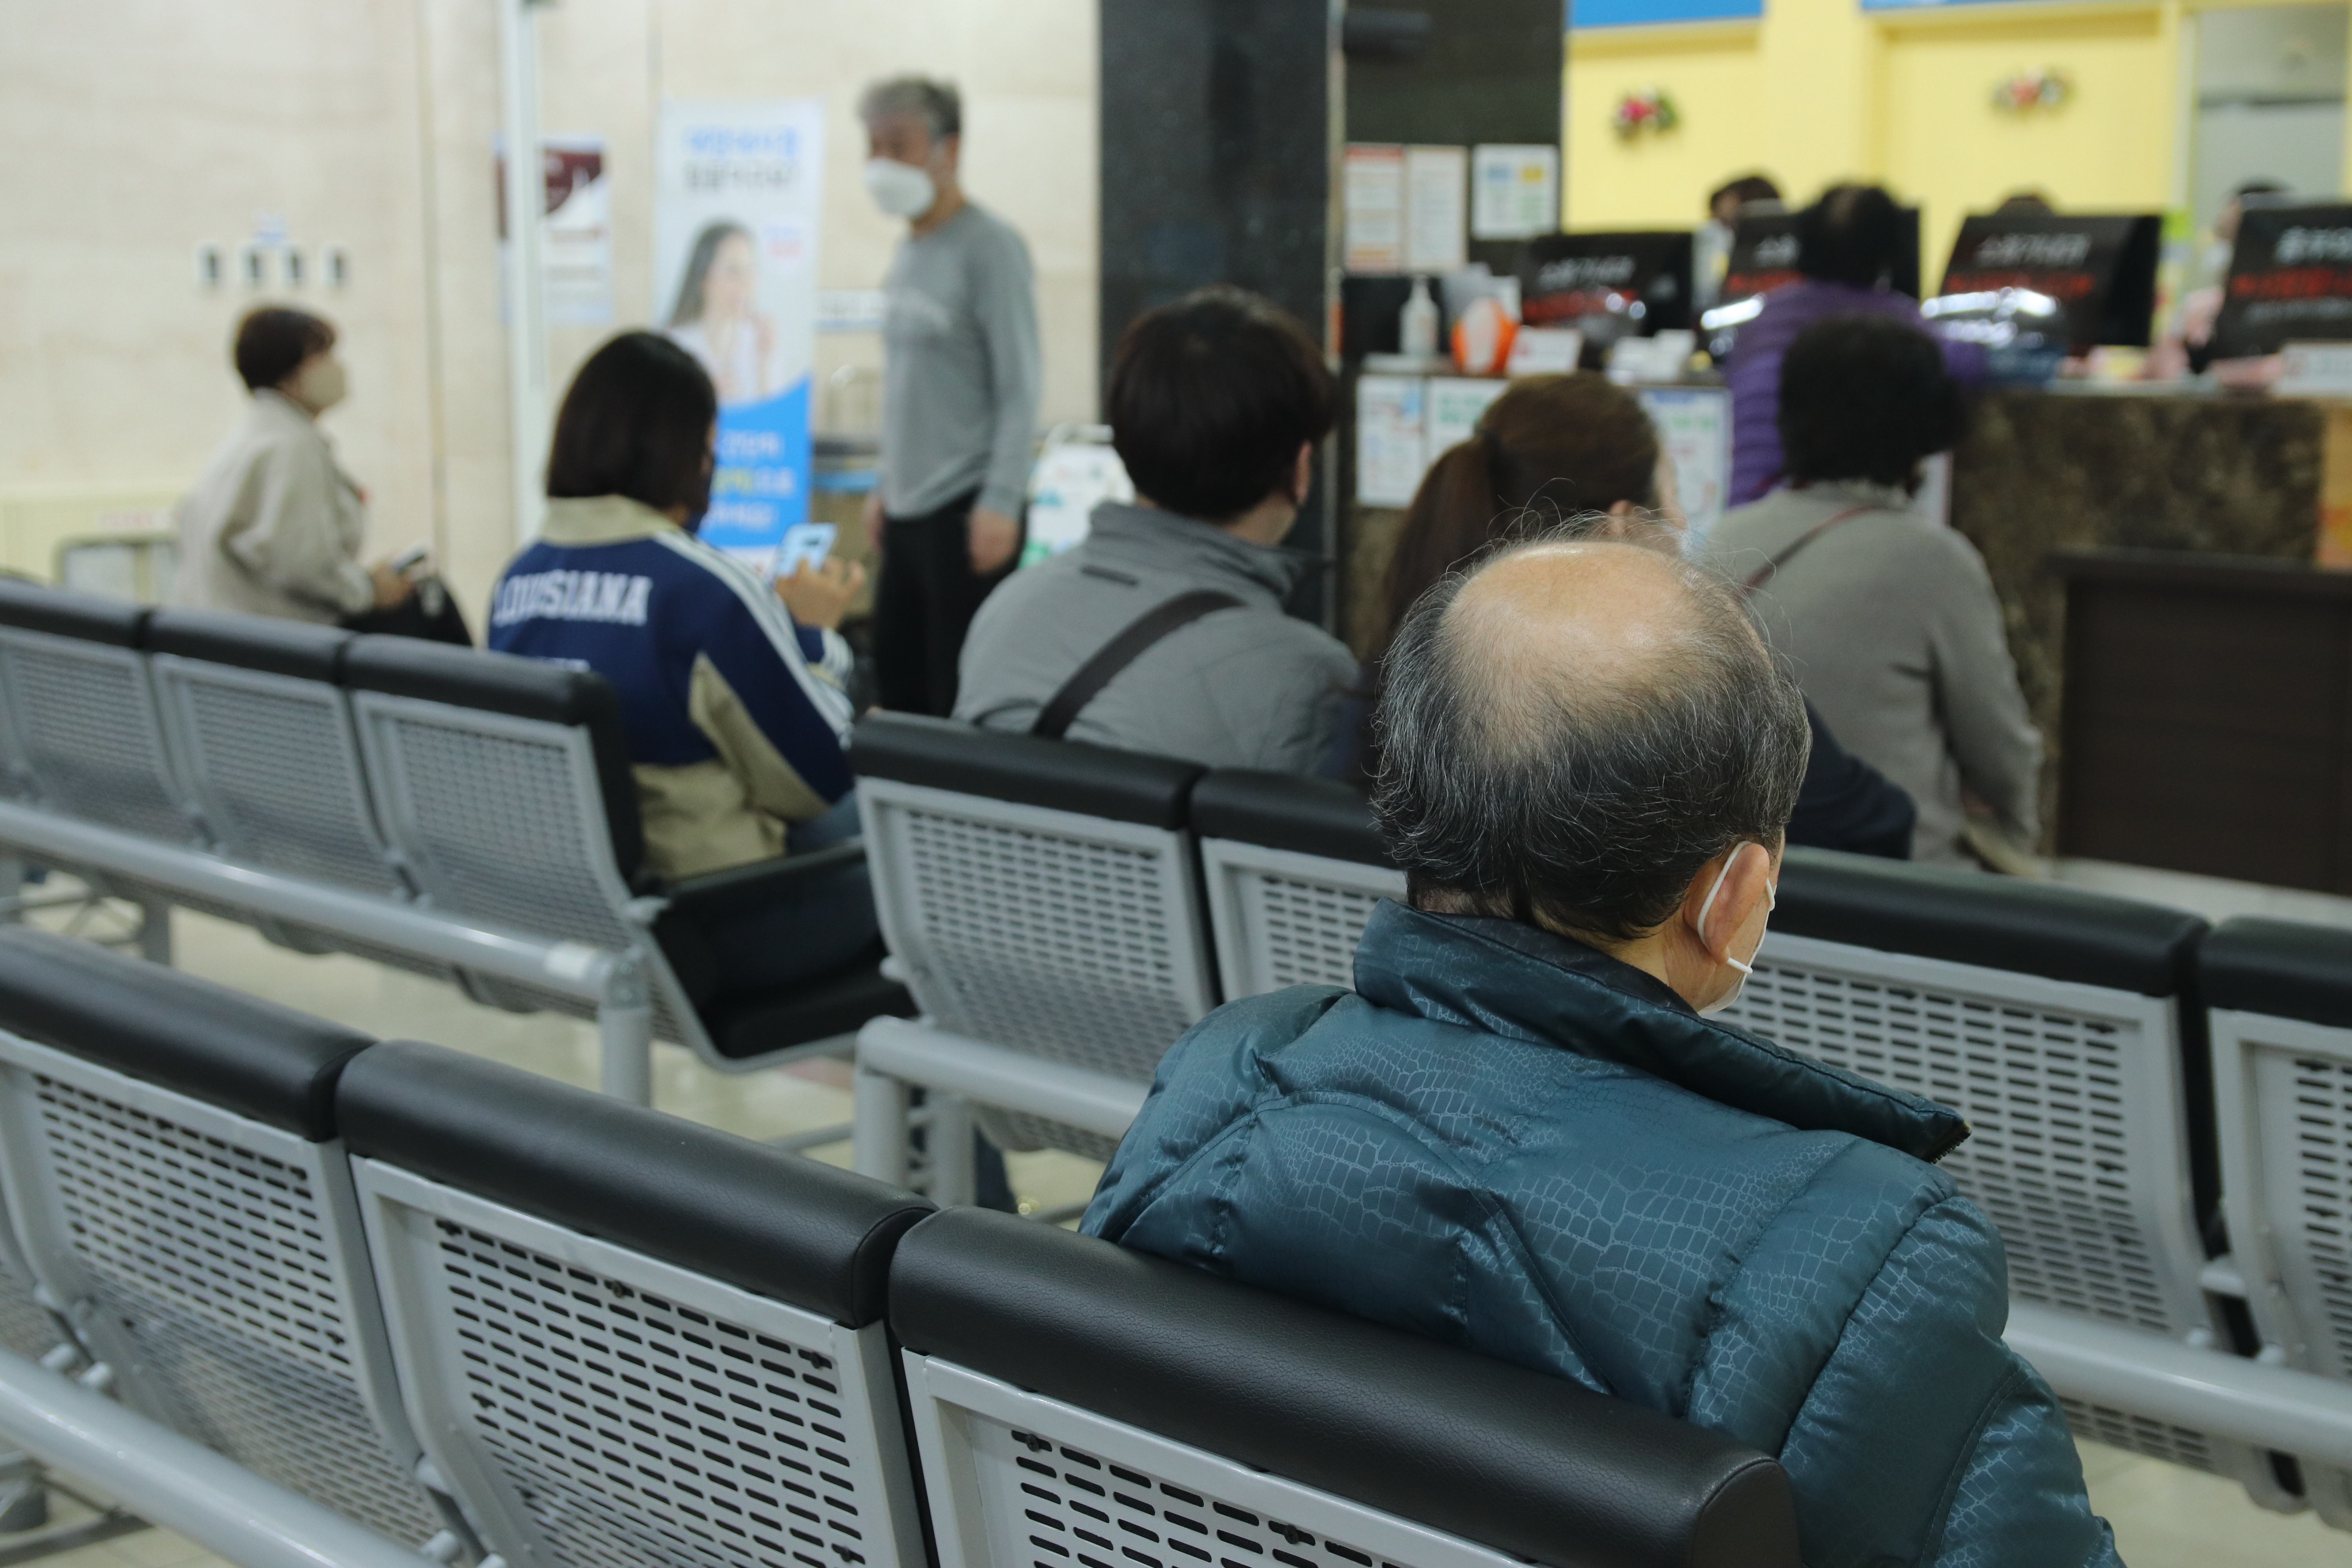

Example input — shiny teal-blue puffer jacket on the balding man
[1084,903,2117,1568]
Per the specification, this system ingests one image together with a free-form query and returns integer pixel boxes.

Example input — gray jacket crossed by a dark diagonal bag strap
[955,503,1355,773]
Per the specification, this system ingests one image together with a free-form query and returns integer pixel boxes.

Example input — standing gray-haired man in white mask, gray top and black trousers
[858,75,1040,717]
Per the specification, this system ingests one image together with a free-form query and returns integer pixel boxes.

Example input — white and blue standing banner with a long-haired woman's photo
[654,99,826,571]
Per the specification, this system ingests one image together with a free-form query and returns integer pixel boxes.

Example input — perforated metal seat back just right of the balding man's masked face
[1724,933,2244,1474]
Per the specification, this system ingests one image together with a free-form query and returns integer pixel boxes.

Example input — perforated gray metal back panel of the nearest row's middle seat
[358,1159,922,1568]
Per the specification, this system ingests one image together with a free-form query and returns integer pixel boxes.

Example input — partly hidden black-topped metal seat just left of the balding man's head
[1190,769,1404,1002]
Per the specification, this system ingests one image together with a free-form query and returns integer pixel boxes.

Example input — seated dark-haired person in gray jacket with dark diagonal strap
[955,287,1355,773]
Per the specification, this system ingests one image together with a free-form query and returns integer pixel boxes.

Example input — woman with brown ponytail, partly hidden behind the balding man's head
[1324,372,1917,860]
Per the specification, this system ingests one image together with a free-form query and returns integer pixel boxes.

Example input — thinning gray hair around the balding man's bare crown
[1374,526,1811,940]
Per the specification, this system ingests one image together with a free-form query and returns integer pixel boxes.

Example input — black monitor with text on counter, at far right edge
[2213,198,2352,360]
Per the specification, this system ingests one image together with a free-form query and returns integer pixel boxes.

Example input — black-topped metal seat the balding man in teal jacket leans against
[889,1208,1799,1568]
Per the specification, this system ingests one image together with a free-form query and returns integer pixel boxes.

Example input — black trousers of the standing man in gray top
[873,491,1021,719]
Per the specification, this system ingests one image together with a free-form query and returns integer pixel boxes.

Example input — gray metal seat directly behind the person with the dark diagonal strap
[849,715,1218,1180]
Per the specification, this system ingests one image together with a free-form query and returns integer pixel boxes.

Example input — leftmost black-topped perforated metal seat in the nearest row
[0,929,456,1547]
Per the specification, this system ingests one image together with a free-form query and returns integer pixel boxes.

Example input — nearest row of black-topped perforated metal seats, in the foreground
[0,929,1797,1568]
